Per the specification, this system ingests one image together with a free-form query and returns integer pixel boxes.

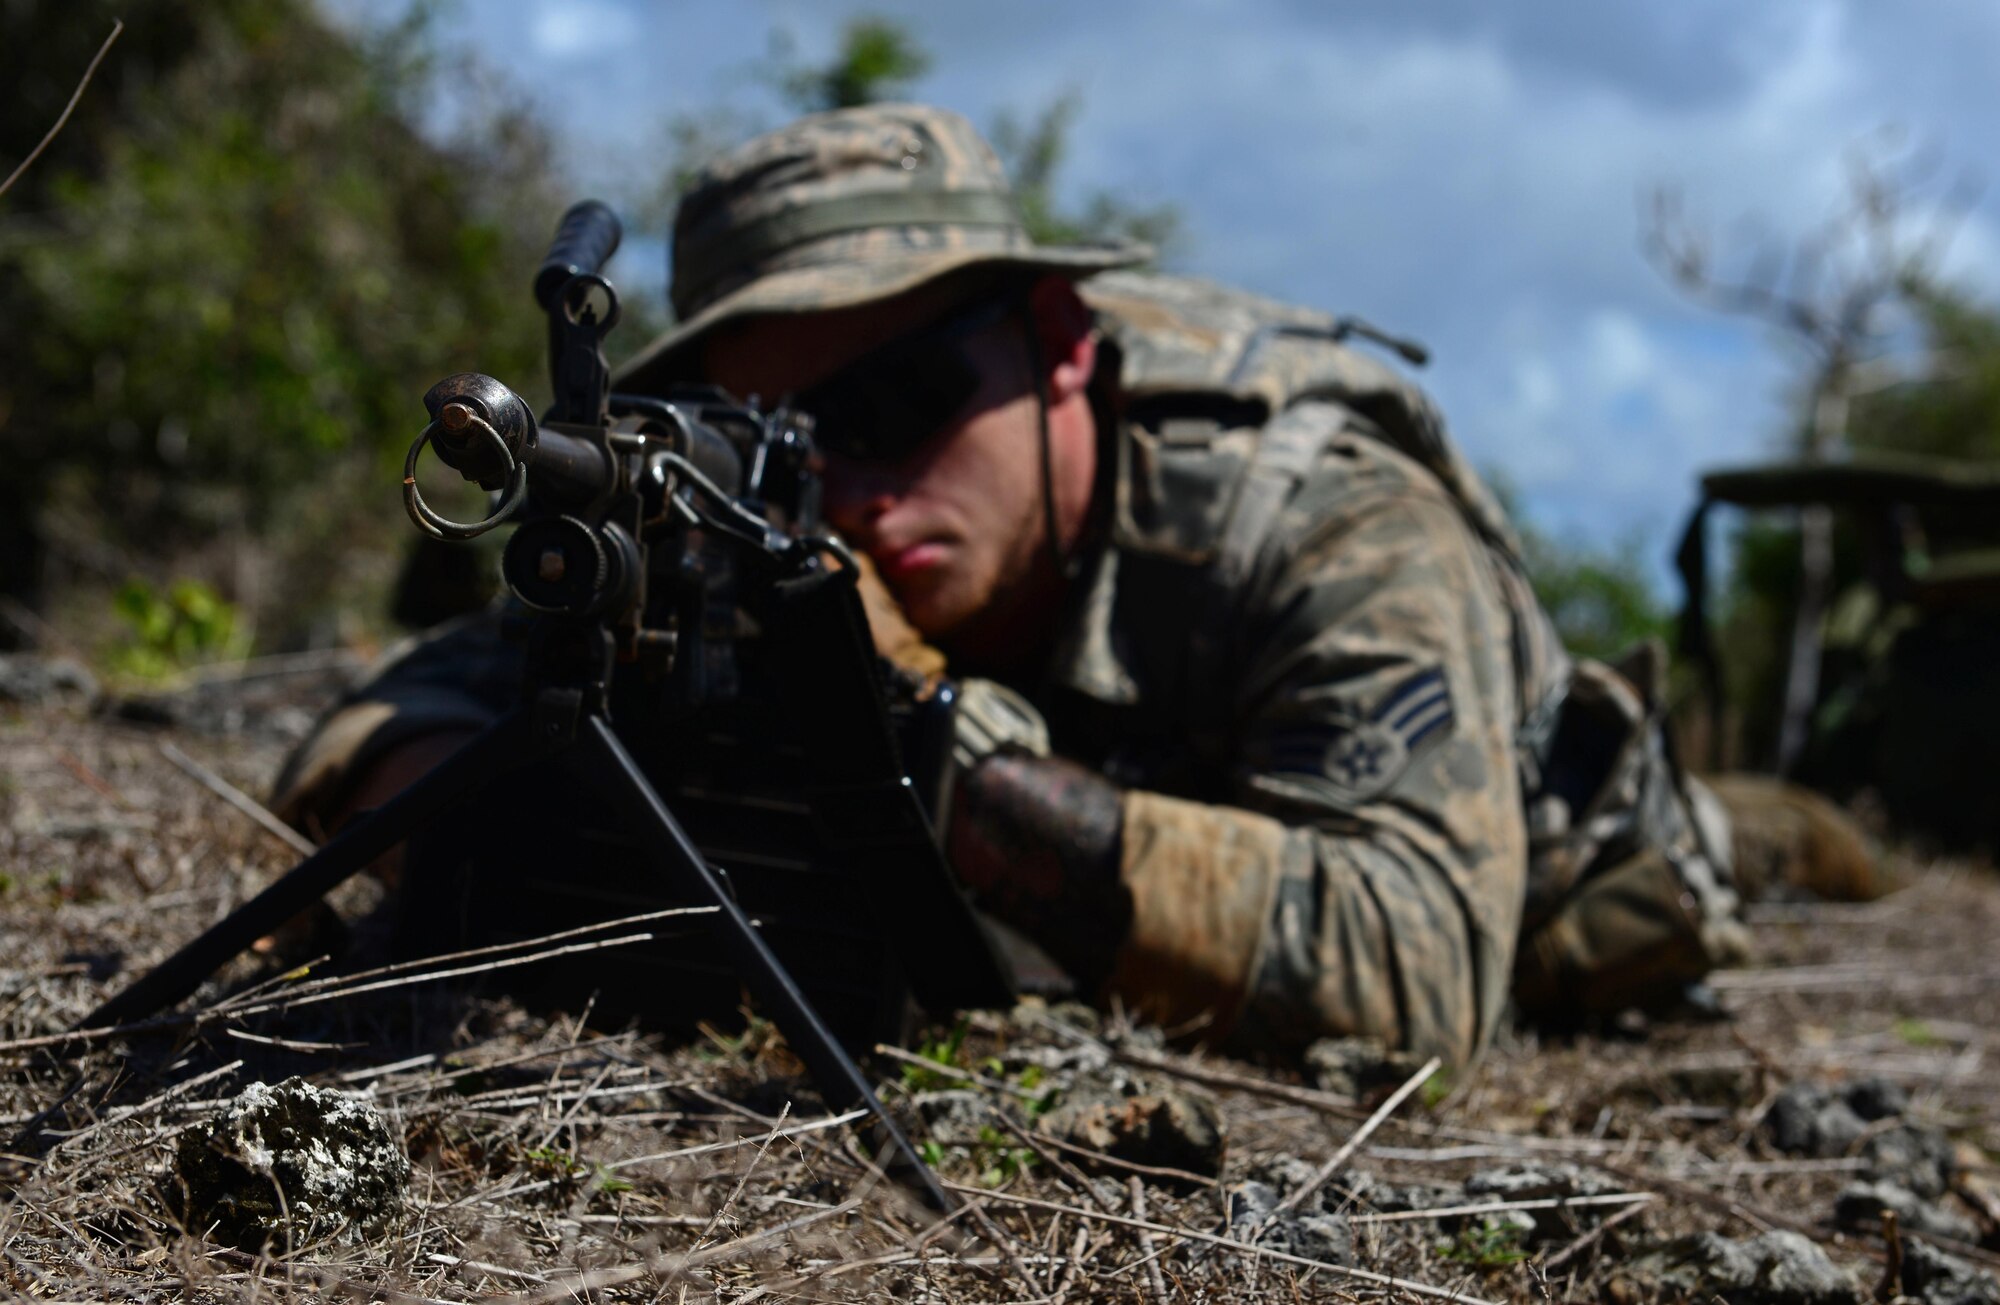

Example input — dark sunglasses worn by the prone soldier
[792,298,1018,462]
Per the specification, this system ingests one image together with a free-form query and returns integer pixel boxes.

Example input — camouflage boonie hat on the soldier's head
[618,104,1150,390]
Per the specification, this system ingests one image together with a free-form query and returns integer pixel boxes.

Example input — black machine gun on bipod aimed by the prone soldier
[80,200,1010,1209]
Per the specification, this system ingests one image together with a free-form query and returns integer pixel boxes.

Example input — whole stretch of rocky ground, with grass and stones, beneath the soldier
[0,659,2000,1305]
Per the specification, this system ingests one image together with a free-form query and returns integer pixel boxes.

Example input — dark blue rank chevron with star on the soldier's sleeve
[1270,667,1454,803]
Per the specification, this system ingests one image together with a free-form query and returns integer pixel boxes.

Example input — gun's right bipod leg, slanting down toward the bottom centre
[572,715,956,1213]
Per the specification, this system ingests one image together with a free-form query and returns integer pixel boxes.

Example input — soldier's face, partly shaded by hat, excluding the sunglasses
[704,296,1044,638]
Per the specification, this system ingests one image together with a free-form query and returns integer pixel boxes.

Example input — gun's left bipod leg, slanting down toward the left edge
[76,709,558,1029]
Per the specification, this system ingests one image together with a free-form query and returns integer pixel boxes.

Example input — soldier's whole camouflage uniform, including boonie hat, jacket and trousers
[288,106,1752,1063]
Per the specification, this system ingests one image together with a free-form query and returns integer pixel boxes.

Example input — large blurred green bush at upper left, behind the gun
[0,0,560,646]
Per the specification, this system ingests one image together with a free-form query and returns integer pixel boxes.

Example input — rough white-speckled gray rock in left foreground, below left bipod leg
[166,1079,410,1249]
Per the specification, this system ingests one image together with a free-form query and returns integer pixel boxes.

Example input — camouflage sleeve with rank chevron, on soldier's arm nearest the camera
[1110,492,1526,1063]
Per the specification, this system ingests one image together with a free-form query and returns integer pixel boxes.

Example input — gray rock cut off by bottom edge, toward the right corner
[1624,1231,1862,1305]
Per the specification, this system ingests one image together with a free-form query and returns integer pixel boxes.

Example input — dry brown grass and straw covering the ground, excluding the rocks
[0,688,2000,1303]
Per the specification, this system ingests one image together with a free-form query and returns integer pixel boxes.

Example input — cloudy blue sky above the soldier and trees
[332,0,2000,578]
